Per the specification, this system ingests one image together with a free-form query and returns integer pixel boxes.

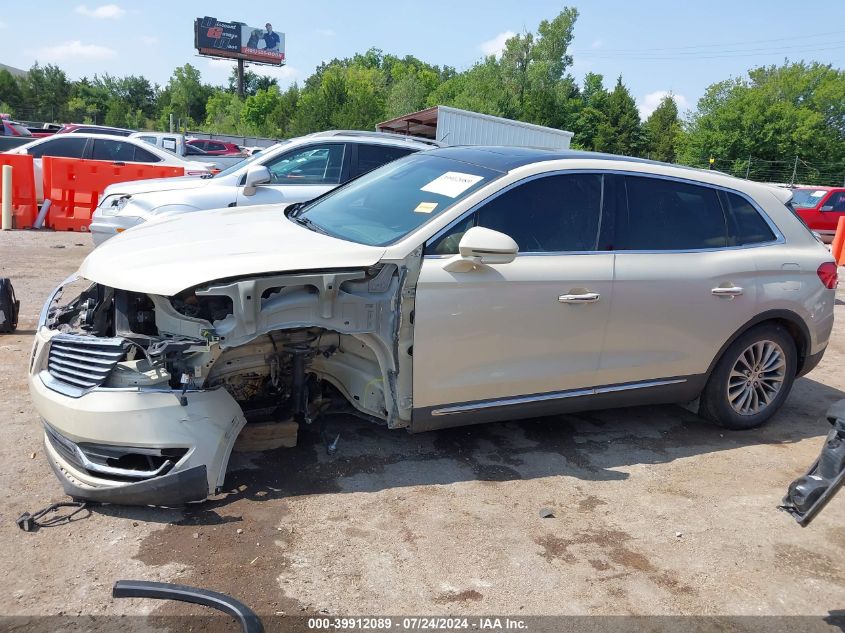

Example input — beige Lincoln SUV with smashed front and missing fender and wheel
[29,147,837,504]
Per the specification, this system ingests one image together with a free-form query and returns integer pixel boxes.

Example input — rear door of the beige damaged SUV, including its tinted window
[597,175,757,387]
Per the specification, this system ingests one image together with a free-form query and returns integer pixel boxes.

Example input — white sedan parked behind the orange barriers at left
[6,133,211,203]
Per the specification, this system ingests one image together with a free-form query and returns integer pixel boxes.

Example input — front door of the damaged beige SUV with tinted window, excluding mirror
[413,173,613,416]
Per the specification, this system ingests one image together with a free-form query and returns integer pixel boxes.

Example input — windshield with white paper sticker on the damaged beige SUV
[295,154,502,246]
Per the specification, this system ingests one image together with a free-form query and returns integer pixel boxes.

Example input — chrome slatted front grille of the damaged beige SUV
[47,334,126,389]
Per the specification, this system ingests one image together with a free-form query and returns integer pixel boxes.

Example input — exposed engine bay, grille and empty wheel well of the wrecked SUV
[42,264,413,454]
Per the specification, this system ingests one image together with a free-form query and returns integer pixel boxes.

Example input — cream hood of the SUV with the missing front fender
[79,205,385,296]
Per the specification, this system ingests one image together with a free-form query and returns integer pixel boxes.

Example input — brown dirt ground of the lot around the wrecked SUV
[0,231,845,630]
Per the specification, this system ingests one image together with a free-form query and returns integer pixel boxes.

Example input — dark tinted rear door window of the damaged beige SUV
[613,176,728,251]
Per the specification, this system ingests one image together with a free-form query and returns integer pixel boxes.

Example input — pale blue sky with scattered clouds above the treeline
[0,0,845,119]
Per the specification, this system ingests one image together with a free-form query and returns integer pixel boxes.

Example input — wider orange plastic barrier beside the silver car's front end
[43,156,185,231]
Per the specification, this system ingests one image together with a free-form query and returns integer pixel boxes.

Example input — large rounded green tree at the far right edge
[679,62,845,184]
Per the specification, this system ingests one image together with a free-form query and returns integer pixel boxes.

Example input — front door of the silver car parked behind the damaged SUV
[232,143,349,206]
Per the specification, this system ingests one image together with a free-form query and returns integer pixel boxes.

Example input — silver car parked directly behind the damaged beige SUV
[91,131,438,244]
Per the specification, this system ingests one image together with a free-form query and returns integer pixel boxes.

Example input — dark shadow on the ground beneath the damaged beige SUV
[153,378,845,525]
